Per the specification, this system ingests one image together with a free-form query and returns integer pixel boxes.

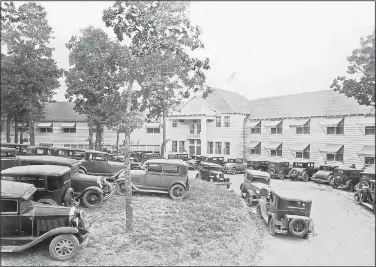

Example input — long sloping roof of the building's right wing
[247,90,375,119]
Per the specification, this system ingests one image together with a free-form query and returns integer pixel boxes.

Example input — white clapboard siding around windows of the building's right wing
[246,116,375,166]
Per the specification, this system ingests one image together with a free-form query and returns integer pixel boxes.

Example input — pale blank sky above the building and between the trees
[16,1,375,101]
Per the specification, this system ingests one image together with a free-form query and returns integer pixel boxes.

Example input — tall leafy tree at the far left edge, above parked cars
[1,2,62,144]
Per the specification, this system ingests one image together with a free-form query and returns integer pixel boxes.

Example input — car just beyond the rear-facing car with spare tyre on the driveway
[240,170,271,206]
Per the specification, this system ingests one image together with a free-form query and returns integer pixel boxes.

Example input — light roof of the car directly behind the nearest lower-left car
[1,165,71,176]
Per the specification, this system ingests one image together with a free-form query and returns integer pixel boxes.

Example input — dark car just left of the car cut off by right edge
[331,166,363,192]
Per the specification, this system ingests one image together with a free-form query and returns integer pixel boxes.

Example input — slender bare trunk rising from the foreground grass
[124,80,134,232]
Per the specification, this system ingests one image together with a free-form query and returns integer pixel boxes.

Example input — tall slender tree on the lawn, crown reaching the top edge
[103,1,209,231]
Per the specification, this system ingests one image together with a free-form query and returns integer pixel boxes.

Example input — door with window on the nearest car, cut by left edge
[0,198,20,239]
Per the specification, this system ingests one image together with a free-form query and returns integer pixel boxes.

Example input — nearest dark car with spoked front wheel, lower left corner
[0,181,89,261]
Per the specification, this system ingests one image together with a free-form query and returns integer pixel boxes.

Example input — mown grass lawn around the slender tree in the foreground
[1,180,265,266]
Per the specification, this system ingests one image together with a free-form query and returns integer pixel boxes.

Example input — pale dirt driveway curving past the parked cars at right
[226,174,375,266]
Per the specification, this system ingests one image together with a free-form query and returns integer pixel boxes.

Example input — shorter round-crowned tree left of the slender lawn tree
[65,27,129,150]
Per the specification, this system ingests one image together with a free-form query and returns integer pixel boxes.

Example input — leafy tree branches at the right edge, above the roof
[330,32,375,106]
